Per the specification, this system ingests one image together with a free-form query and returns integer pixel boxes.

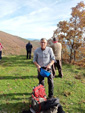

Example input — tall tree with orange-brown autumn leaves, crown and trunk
[53,2,85,62]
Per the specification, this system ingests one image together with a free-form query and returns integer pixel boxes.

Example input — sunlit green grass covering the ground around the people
[0,56,85,113]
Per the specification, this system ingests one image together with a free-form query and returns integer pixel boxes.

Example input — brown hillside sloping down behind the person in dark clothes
[0,31,39,55]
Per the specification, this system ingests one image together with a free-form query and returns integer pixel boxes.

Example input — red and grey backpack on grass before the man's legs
[31,84,47,113]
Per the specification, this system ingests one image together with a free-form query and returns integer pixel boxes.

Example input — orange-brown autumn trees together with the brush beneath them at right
[52,2,85,63]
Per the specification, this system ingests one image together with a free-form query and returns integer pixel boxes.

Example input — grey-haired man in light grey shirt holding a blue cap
[33,38,55,98]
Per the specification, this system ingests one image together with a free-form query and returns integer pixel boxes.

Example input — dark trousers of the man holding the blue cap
[38,70,54,98]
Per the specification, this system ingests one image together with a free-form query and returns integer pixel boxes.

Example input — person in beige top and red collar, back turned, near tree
[51,38,63,78]
